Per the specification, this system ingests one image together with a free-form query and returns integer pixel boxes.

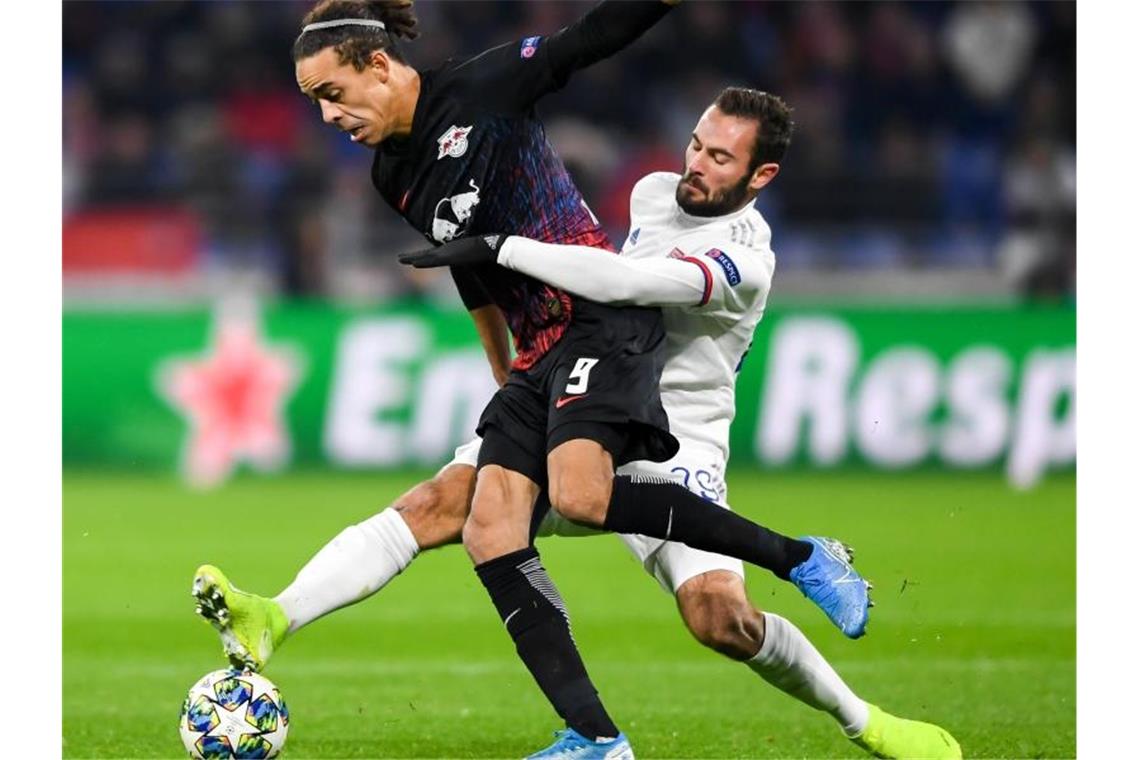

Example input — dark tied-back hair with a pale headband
[293,0,420,71]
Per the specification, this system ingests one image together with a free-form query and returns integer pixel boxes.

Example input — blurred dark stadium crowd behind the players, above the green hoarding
[63,0,1076,299]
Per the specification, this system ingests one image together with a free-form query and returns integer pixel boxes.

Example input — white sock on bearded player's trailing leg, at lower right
[748,612,870,736]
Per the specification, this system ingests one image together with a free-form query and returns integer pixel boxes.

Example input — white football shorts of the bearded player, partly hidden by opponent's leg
[448,438,744,594]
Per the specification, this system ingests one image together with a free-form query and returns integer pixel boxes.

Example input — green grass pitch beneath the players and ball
[63,469,1076,759]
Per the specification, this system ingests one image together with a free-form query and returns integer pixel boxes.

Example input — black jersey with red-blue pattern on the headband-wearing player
[372,2,667,369]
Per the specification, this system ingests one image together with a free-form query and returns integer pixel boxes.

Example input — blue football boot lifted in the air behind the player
[788,536,874,638]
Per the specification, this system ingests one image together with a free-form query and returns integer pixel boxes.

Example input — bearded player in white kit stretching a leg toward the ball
[200,88,961,758]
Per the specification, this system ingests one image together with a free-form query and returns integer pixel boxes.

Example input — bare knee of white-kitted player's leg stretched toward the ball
[393,465,475,550]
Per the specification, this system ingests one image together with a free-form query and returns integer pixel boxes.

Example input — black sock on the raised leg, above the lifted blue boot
[602,475,812,580]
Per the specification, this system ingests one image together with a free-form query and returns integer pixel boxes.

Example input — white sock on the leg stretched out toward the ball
[275,507,420,634]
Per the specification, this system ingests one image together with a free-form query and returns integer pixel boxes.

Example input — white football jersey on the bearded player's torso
[621,172,775,461]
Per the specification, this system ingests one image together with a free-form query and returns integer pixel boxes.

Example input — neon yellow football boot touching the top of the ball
[190,565,288,671]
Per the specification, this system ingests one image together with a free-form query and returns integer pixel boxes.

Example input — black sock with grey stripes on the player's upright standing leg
[475,547,618,739]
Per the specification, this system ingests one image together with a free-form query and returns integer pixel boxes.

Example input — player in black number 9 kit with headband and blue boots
[195,0,866,757]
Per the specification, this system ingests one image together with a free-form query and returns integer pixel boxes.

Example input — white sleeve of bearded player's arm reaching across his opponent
[498,236,771,312]
